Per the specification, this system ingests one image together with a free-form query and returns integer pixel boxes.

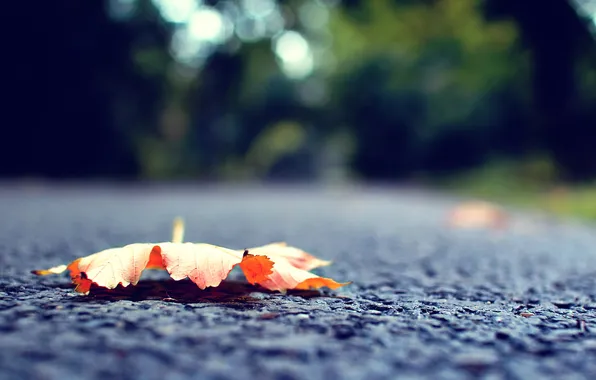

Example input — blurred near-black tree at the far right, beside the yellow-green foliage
[485,0,596,180]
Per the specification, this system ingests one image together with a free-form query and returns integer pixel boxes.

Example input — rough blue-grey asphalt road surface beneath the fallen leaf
[0,185,596,380]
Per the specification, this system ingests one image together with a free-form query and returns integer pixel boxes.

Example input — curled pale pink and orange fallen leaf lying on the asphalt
[32,219,349,294]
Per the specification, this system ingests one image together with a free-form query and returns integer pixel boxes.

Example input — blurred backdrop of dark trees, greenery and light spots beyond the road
[0,0,596,217]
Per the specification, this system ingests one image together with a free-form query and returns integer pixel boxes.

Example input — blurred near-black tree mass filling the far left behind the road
[0,0,168,178]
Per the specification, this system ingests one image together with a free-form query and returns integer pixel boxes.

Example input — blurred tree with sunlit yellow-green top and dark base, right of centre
[331,0,530,179]
